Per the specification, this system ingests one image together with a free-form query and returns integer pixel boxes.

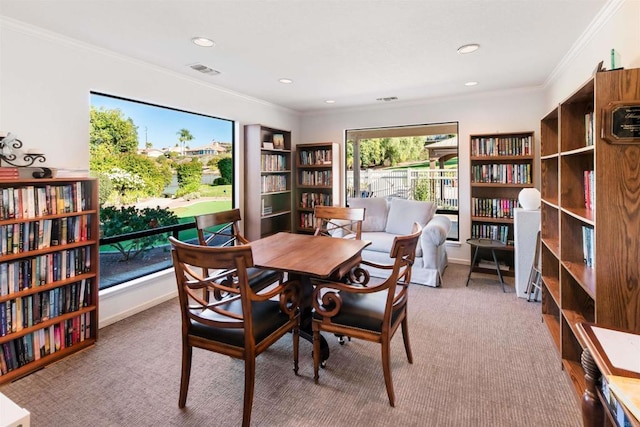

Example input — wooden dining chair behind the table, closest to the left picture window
[194,209,283,292]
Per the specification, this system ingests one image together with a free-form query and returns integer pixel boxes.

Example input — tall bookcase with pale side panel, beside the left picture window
[244,124,292,240]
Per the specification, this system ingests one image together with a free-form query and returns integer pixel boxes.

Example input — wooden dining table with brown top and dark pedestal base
[251,232,371,361]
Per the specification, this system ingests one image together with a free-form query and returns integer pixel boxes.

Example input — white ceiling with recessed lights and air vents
[0,0,608,112]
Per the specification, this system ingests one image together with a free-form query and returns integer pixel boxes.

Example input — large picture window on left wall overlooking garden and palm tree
[89,93,236,289]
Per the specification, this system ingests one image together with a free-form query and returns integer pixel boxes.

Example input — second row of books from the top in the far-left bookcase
[0,215,91,255]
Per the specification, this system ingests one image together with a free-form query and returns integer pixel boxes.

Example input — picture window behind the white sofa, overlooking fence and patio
[345,122,459,240]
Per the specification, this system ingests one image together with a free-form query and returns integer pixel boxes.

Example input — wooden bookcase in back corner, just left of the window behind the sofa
[294,142,340,233]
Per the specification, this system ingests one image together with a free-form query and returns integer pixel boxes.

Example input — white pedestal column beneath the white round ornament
[514,208,540,298]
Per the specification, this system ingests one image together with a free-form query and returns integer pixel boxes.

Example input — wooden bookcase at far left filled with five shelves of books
[0,178,99,384]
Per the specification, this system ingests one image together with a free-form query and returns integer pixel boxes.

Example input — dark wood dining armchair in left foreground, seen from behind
[169,237,301,427]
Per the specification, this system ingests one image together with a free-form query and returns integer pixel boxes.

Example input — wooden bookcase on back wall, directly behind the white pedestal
[470,132,535,276]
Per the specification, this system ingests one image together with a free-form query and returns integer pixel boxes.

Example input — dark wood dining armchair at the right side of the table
[312,223,422,406]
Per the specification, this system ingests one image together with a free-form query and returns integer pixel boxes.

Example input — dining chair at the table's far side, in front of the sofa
[314,206,365,240]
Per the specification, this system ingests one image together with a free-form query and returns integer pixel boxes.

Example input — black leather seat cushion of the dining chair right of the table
[313,292,400,332]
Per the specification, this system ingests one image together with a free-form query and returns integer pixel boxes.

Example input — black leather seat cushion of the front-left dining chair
[189,299,289,347]
